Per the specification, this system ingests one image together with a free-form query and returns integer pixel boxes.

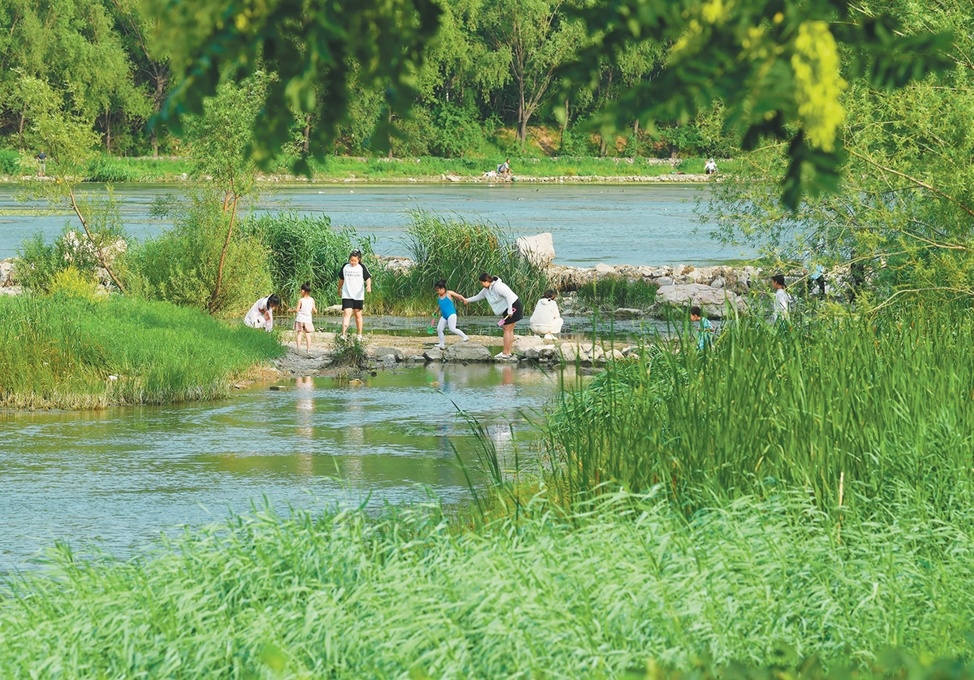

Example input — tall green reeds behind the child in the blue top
[372,212,548,314]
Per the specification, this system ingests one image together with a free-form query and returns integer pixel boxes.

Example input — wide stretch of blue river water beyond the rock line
[0,184,750,266]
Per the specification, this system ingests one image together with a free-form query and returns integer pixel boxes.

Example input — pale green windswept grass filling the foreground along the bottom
[0,493,974,678]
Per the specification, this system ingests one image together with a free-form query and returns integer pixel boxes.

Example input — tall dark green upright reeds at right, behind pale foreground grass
[547,307,974,509]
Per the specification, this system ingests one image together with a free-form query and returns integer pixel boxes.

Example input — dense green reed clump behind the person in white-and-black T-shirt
[242,213,376,308]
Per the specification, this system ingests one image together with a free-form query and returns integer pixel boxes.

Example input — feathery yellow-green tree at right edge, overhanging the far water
[710,0,974,304]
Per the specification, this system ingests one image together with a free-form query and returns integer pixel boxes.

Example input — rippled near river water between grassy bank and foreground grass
[0,364,572,572]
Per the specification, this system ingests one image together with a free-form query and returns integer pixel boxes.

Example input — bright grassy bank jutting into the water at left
[0,294,282,408]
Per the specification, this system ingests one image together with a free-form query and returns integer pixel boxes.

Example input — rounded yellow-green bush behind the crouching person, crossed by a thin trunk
[127,196,273,316]
